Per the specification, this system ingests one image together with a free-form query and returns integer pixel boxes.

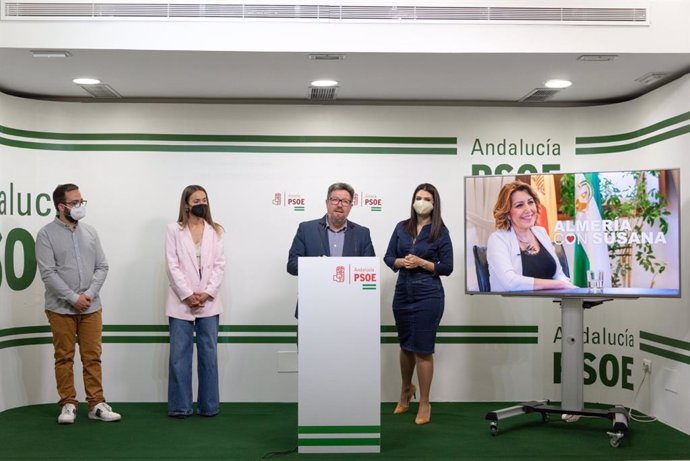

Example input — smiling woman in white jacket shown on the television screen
[486,181,576,292]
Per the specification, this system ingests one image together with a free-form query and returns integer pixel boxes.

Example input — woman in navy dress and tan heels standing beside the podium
[384,183,453,424]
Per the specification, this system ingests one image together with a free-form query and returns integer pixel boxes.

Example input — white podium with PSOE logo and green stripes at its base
[297,257,381,453]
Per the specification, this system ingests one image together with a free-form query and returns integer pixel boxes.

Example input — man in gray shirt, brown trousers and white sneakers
[36,184,121,424]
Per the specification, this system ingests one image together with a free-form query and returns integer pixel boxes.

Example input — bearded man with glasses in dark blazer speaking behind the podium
[287,182,376,288]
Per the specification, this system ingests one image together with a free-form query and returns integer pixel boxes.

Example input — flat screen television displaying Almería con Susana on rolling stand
[464,169,681,298]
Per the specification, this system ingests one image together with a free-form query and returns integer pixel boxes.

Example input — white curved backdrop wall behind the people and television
[0,77,690,433]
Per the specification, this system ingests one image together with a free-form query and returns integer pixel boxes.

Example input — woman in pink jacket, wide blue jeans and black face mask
[165,185,225,418]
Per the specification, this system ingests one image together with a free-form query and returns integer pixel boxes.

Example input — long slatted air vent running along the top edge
[0,0,649,26]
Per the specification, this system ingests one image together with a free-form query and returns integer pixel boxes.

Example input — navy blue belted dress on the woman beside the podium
[383,221,453,354]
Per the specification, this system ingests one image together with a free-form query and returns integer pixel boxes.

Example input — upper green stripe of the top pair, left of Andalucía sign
[0,125,458,144]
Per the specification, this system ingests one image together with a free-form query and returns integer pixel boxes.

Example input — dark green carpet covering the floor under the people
[0,400,690,461]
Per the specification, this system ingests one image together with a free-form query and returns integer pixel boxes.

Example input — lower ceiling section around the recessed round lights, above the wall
[0,48,690,105]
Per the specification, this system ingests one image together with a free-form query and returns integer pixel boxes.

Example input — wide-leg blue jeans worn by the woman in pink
[168,315,220,416]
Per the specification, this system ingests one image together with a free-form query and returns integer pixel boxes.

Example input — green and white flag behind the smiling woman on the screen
[572,173,611,287]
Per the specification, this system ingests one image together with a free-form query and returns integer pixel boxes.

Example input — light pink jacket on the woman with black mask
[165,222,225,320]
